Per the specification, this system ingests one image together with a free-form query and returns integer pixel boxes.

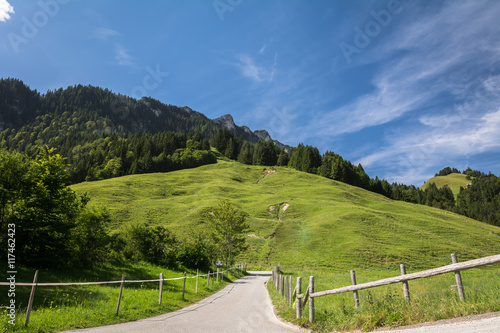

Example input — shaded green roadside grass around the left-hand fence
[0,263,243,332]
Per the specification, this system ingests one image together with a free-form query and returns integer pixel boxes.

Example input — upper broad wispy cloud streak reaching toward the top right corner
[309,1,500,136]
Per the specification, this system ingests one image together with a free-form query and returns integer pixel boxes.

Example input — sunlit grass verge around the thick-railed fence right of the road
[268,262,500,332]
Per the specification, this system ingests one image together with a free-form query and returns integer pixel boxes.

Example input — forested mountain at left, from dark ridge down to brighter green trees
[0,79,286,183]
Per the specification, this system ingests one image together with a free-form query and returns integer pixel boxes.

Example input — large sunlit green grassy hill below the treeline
[72,161,500,271]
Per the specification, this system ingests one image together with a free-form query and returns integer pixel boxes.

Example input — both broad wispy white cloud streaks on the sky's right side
[304,1,500,182]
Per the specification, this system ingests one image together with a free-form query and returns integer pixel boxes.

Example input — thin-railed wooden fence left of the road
[0,263,247,326]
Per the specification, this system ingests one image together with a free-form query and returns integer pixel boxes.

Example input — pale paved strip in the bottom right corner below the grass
[377,312,500,333]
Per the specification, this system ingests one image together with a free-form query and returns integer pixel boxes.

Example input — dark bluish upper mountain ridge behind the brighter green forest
[0,79,284,148]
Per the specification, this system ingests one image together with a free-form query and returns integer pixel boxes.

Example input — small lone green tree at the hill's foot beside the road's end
[208,200,249,265]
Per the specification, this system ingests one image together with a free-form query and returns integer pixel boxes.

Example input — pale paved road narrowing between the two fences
[62,272,306,333]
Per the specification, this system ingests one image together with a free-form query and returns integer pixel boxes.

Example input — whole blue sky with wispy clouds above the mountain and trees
[0,0,500,186]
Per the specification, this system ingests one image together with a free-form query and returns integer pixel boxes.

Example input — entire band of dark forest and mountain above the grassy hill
[0,79,500,225]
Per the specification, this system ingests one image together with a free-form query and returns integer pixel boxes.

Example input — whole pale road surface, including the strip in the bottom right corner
[60,272,500,333]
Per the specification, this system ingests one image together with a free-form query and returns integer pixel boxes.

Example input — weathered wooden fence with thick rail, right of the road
[272,254,500,323]
